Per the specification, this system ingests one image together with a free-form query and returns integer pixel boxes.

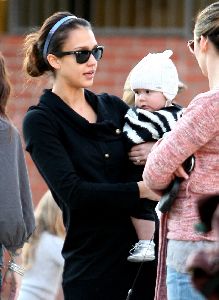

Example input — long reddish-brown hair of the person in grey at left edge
[0,52,11,117]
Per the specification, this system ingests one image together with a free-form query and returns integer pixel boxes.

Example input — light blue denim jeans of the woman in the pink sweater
[166,267,205,300]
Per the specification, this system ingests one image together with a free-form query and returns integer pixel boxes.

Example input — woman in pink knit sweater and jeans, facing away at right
[143,2,219,300]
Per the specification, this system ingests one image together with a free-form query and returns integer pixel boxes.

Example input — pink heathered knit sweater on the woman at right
[143,90,219,300]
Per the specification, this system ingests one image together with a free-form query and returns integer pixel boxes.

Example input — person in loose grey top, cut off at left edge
[0,53,35,298]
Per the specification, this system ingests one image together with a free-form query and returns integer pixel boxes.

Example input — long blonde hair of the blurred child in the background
[22,190,65,269]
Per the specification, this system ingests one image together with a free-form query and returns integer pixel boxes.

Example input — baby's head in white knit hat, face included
[130,50,179,111]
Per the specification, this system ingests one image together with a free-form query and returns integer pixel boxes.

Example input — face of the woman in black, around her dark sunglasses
[55,27,97,88]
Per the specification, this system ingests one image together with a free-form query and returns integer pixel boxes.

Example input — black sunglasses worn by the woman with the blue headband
[55,46,104,64]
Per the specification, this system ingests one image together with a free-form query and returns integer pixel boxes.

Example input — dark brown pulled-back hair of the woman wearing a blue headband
[23,12,91,77]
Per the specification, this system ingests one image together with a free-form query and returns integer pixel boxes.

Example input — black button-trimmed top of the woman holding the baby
[23,90,142,283]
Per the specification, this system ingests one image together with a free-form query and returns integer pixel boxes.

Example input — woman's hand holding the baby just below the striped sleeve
[128,142,155,165]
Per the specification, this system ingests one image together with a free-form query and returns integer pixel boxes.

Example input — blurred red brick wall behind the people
[0,36,208,203]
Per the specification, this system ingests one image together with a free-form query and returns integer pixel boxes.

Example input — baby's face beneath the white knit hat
[134,89,166,111]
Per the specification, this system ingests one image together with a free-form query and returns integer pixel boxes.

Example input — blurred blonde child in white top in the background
[18,190,65,300]
